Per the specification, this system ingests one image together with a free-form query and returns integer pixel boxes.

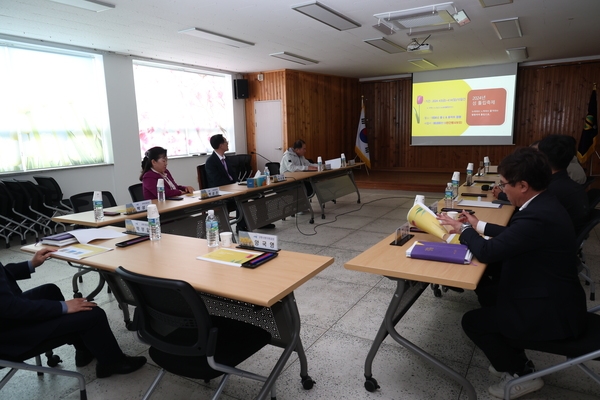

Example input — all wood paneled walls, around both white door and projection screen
[245,60,600,175]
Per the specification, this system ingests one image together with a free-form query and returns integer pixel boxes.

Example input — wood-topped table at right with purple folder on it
[344,197,514,399]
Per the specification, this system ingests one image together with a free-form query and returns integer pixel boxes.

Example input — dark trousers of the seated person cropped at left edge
[19,284,123,364]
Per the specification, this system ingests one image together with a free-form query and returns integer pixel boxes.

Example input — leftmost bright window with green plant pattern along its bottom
[0,40,109,173]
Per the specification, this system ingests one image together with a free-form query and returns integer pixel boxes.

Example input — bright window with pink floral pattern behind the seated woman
[133,61,235,157]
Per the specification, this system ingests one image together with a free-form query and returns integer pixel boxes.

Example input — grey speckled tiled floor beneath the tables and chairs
[0,190,600,400]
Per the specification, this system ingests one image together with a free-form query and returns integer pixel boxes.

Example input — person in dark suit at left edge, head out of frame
[0,248,146,378]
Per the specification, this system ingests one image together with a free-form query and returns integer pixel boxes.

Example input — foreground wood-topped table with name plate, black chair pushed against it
[21,231,333,399]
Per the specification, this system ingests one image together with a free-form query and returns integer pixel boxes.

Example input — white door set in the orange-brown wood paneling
[254,100,283,171]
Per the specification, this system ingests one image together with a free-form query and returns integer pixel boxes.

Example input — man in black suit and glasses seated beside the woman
[205,134,275,231]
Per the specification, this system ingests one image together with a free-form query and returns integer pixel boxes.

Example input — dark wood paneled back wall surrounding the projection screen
[360,61,600,174]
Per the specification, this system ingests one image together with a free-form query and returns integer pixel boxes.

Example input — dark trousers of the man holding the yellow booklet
[462,307,527,374]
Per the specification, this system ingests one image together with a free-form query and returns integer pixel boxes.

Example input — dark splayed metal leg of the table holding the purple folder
[365,278,477,400]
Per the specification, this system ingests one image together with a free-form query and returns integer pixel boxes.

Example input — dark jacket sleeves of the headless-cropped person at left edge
[0,262,62,324]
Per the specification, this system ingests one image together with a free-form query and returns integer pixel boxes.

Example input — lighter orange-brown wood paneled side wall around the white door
[244,70,360,166]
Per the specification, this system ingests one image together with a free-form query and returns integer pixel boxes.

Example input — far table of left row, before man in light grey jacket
[285,162,364,219]
